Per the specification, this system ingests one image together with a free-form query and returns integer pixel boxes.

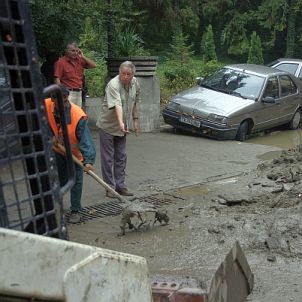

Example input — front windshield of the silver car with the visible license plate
[201,68,265,100]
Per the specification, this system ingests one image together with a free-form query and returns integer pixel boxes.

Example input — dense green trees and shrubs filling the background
[28,0,302,101]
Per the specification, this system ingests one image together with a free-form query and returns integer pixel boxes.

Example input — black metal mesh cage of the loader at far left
[0,0,66,238]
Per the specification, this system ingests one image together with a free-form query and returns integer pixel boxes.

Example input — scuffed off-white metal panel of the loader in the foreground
[0,228,152,302]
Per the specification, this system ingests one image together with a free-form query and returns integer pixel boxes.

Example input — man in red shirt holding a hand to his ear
[54,42,96,107]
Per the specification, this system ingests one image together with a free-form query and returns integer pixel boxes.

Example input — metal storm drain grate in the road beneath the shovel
[65,196,173,224]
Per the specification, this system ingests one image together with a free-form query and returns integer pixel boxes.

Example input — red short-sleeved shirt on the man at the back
[54,55,88,89]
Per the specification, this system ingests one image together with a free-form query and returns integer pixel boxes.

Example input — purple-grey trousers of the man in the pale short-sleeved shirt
[99,129,127,190]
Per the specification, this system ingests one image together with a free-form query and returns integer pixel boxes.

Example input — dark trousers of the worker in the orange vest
[55,153,83,212]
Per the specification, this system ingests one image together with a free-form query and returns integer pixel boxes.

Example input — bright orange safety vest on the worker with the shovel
[45,98,88,161]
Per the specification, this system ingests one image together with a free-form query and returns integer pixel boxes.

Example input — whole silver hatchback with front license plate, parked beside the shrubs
[163,64,302,141]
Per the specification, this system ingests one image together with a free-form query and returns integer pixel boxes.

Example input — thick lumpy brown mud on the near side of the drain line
[69,129,302,302]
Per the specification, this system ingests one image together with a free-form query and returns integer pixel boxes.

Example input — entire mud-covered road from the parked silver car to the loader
[65,131,302,302]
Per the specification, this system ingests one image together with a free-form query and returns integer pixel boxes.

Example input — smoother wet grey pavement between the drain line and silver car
[78,128,281,206]
